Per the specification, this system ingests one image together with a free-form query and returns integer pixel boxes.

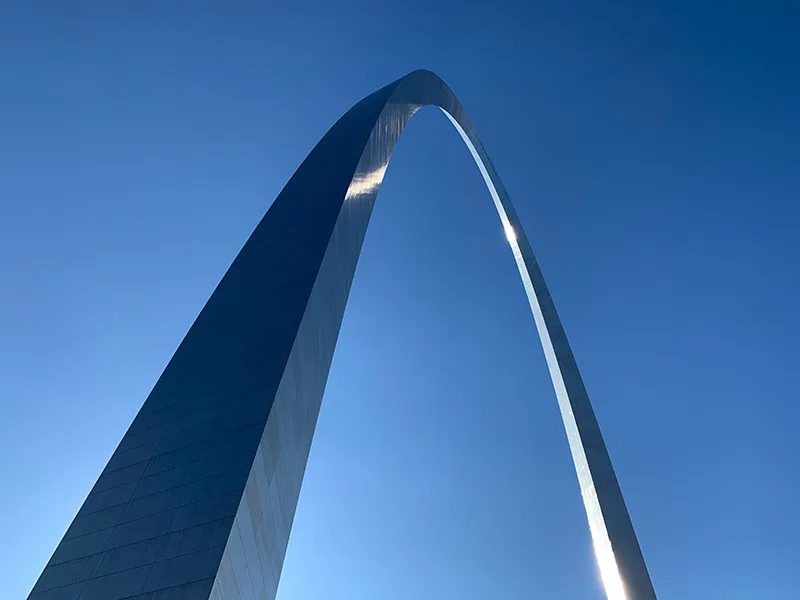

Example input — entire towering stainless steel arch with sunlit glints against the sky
[29,71,655,600]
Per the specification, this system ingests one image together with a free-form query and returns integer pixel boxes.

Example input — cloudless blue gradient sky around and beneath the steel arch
[0,0,800,600]
